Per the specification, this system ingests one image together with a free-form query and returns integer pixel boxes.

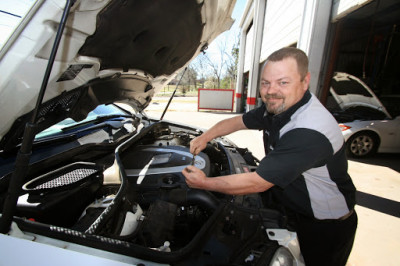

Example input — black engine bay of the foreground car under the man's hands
[4,122,285,265]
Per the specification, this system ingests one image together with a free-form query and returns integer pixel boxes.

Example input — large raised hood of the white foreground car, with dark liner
[0,0,235,150]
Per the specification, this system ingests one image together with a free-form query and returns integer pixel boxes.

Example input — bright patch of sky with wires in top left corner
[0,0,37,50]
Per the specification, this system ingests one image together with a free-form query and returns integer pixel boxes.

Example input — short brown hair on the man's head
[266,47,308,80]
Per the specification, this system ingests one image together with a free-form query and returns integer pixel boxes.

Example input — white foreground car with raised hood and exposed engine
[0,0,304,265]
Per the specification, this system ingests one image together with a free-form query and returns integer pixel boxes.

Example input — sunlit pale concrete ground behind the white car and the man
[146,97,400,266]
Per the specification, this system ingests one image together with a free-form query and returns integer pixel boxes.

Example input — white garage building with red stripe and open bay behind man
[235,0,400,112]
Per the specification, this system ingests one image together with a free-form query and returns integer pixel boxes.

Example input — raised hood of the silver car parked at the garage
[330,72,391,118]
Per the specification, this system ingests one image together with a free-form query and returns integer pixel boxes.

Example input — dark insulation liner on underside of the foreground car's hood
[79,0,203,77]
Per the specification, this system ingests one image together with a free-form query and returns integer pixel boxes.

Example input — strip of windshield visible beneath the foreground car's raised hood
[35,104,127,140]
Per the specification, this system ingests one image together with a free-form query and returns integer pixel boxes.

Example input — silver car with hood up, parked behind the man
[328,72,400,157]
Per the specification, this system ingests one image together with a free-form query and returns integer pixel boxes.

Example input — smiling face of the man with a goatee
[260,57,310,114]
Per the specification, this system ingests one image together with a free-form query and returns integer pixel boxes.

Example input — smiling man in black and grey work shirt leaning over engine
[182,48,357,266]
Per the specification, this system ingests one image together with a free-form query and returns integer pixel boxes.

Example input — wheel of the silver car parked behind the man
[346,132,379,158]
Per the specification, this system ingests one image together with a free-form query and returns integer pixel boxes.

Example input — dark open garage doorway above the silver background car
[320,0,400,106]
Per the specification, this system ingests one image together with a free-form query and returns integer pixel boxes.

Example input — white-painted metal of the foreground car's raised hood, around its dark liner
[0,0,235,139]
